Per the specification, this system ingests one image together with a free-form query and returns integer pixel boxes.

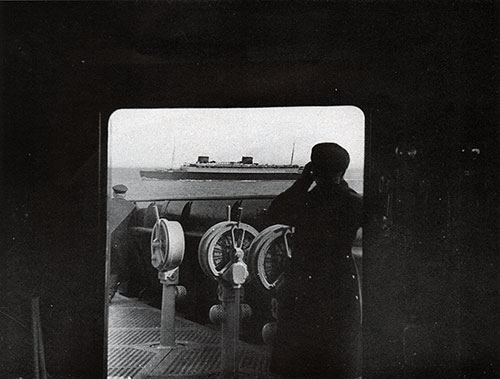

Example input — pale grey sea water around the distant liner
[108,168,363,206]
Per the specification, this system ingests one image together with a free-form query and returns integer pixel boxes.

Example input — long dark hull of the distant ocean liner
[140,170,300,180]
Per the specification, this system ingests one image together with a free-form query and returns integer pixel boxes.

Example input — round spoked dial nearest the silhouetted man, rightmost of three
[249,224,293,291]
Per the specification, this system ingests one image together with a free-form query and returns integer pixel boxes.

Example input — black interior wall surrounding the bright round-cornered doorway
[0,2,499,378]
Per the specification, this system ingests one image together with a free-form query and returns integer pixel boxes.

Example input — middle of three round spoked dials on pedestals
[198,221,259,279]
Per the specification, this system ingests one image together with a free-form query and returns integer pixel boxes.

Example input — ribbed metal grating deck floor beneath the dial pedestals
[108,294,275,379]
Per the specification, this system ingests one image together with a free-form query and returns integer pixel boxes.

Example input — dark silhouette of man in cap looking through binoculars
[268,143,362,379]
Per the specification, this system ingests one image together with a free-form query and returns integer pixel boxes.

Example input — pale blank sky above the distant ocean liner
[109,106,365,168]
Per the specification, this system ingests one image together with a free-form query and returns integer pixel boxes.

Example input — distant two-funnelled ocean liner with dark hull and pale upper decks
[140,156,303,180]
